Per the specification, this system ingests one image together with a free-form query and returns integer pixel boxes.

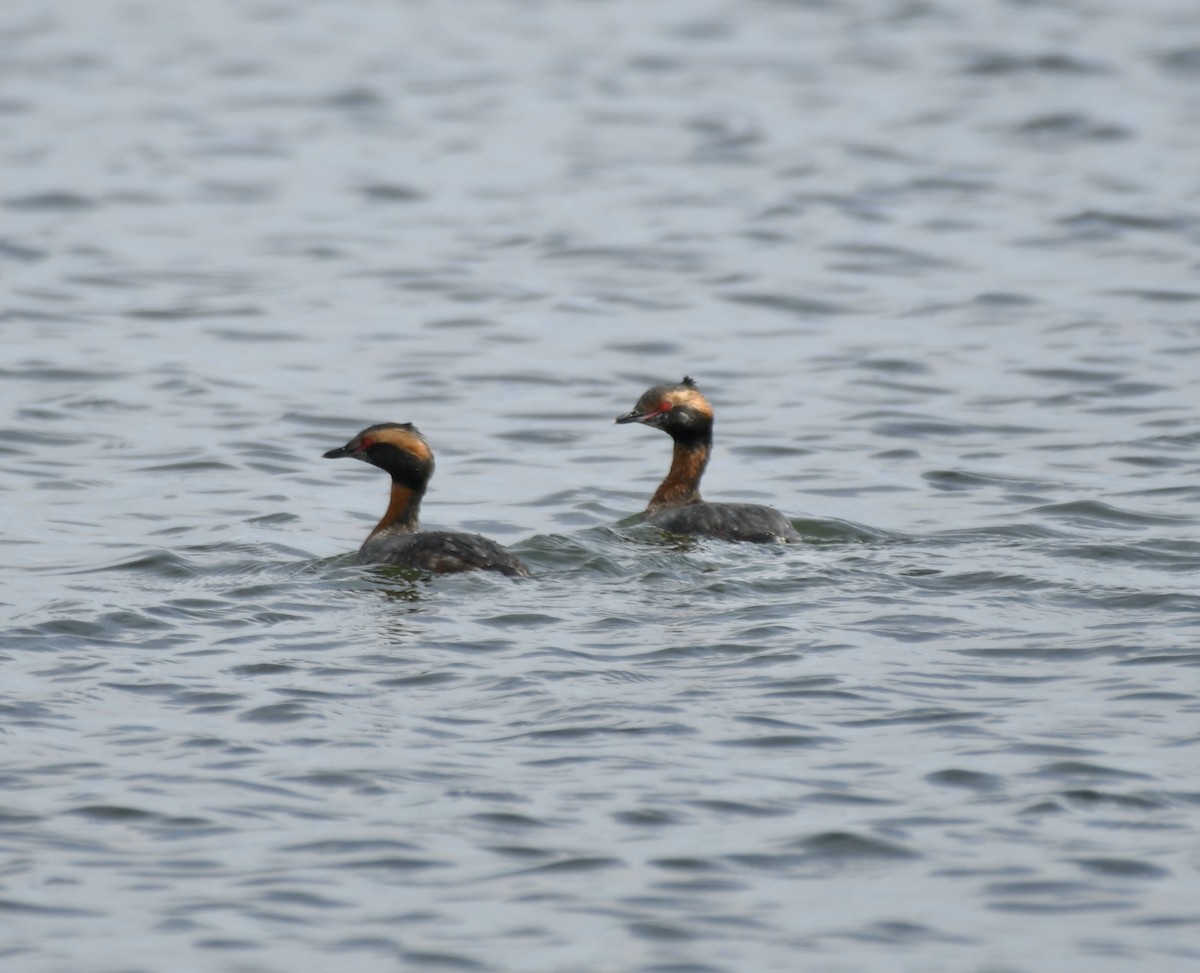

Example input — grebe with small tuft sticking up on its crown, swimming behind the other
[614,377,800,543]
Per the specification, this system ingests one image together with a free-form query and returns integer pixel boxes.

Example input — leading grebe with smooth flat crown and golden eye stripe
[324,422,529,578]
